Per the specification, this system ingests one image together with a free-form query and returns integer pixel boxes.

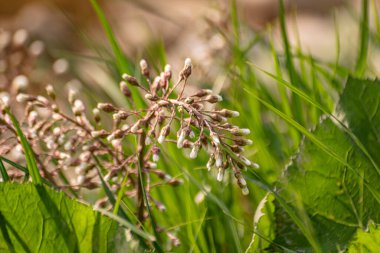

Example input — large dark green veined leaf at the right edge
[275,78,380,252]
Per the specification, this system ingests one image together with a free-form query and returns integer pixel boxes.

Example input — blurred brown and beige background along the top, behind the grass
[0,0,379,104]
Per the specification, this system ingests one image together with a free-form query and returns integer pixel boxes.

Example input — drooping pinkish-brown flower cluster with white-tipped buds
[0,56,258,245]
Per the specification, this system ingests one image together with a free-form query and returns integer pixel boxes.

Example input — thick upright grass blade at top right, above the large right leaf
[355,0,369,77]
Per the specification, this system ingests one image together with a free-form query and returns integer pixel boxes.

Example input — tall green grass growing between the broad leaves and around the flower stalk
[0,0,380,252]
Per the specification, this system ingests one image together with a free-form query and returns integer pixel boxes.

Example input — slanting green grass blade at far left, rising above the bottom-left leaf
[6,109,42,184]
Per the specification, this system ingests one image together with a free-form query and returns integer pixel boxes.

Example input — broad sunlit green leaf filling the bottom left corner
[0,183,124,252]
